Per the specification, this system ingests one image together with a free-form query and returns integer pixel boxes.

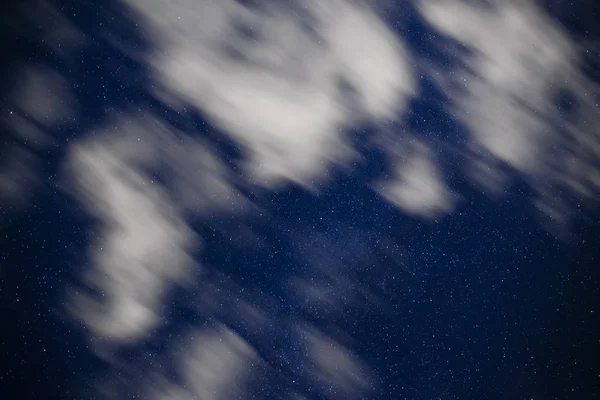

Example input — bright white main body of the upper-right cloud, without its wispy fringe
[421,1,573,172]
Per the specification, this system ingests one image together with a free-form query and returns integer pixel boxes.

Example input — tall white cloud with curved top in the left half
[65,115,242,343]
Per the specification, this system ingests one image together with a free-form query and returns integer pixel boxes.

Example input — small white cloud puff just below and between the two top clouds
[376,139,455,218]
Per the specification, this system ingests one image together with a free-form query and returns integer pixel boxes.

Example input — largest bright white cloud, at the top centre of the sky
[124,0,414,188]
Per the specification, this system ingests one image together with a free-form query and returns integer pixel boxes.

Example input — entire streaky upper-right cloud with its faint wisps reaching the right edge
[419,0,600,222]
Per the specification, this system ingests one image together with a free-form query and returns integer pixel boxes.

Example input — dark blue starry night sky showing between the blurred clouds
[0,1,600,400]
